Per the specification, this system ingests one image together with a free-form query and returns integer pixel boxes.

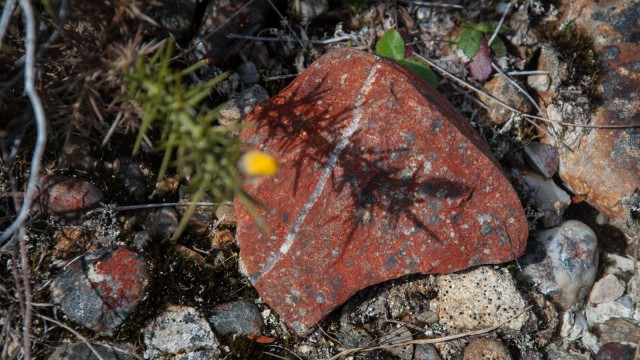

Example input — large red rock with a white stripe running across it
[236,49,527,334]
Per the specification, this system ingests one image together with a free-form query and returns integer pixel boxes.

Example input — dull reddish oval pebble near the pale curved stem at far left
[31,174,104,217]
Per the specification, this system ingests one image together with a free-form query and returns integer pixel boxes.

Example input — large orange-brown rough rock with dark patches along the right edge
[548,0,640,235]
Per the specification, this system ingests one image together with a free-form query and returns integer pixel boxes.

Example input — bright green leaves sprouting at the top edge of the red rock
[376,29,438,87]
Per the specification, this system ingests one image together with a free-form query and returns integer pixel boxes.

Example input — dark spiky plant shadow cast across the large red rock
[248,74,474,246]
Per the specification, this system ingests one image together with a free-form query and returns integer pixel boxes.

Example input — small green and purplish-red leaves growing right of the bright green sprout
[457,22,508,81]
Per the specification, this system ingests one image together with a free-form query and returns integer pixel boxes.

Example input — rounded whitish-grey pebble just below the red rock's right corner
[520,220,598,309]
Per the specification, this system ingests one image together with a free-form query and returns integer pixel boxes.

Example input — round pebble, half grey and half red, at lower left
[51,247,150,335]
